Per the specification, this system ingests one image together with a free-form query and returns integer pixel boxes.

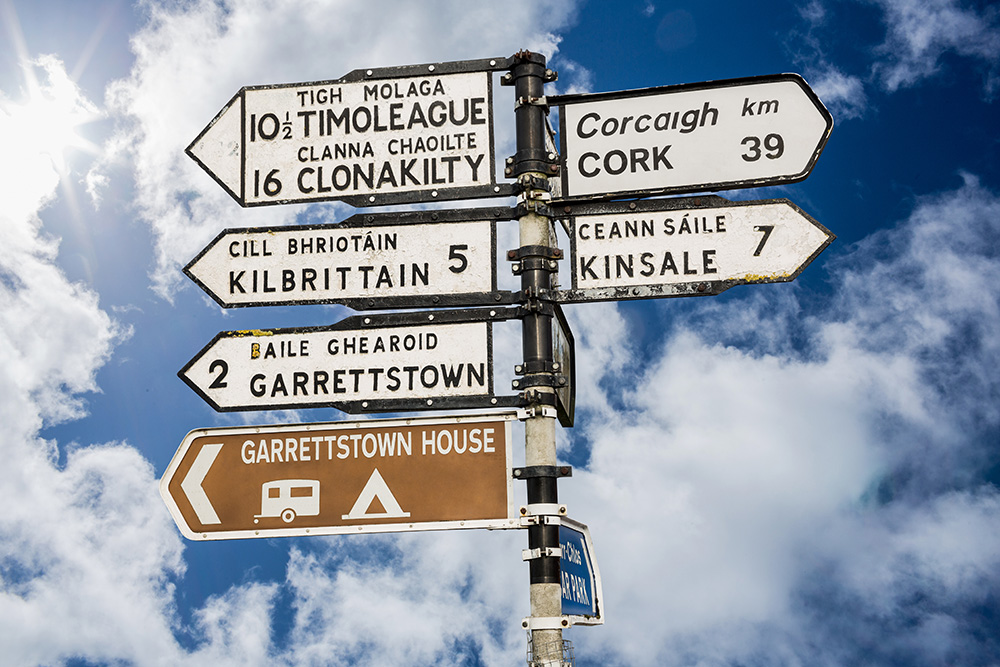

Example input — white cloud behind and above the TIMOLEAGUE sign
[99,0,575,297]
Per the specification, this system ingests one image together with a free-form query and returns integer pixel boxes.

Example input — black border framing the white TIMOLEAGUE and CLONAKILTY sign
[218,58,516,208]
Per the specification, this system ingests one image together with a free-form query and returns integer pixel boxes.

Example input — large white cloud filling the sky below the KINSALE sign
[561,176,1000,665]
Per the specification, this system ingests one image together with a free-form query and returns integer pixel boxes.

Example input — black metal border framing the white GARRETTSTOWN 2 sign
[177,308,527,414]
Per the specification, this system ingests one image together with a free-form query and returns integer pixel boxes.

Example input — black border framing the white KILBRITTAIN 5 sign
[183,207,518,310]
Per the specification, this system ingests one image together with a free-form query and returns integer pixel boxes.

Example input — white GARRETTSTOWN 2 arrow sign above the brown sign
[178,308,520,413]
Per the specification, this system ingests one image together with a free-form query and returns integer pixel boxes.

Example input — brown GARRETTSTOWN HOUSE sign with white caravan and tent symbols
[160,412,519,540]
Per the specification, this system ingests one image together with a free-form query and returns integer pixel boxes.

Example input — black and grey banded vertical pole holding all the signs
[504,51,563,667]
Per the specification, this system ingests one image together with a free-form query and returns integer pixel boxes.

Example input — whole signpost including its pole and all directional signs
[174,52,834,665]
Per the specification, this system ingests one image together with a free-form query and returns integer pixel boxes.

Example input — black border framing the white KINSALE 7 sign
[551,195,837,303]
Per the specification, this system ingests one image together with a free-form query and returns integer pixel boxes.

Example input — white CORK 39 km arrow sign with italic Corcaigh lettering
[548,74,833,201]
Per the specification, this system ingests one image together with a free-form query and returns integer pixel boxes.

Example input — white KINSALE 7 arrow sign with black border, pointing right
[555,195,835,302]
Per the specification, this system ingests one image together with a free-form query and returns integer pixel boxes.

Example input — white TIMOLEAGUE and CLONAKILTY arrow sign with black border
[187,58,513,206]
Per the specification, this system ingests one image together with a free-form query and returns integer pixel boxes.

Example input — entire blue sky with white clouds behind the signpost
[0,0,1000,666]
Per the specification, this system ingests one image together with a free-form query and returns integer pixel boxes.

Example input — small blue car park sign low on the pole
[559,518,603,623]
